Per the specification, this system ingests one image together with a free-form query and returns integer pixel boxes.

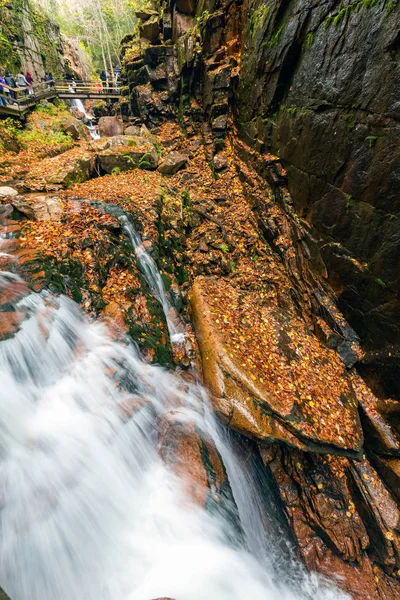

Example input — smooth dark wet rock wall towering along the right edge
[233,0,400,393]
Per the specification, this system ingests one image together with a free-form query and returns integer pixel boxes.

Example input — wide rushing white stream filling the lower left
[0,207,345,600]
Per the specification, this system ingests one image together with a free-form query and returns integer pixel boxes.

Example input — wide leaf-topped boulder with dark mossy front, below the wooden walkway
[97,135,158,173]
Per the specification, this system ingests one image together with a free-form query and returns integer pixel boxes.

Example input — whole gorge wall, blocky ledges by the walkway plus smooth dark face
[123,0,400,395]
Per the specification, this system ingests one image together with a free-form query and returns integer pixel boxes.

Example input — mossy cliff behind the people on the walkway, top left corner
[0,0,90,82]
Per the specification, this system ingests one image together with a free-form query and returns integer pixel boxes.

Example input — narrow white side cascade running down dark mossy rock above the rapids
[119,215,185,344]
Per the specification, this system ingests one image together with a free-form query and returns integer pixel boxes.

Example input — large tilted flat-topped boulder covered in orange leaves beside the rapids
[190,277,363,457]
